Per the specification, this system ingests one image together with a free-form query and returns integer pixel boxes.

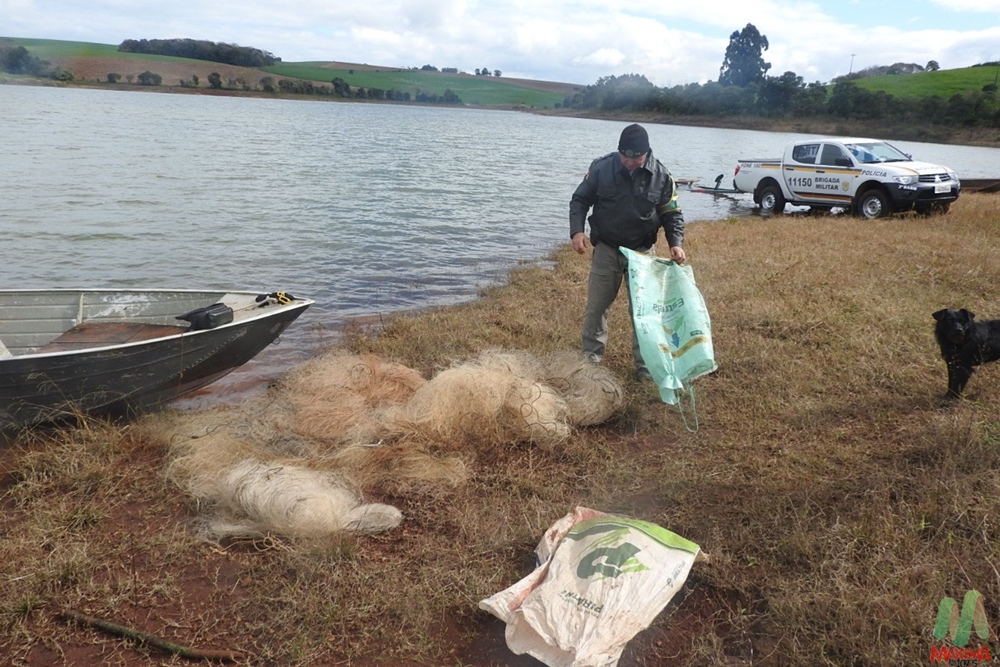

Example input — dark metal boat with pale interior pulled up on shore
[0,289,314,431]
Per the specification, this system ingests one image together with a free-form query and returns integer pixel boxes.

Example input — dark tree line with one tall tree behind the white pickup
[559,23,1000,127]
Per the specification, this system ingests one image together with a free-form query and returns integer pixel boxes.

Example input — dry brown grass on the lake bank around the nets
[0,195,1000,667]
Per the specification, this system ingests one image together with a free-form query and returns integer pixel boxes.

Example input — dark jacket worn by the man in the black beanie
[569,151,684,250]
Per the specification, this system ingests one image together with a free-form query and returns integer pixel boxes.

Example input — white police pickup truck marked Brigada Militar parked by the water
[733,138,961,218]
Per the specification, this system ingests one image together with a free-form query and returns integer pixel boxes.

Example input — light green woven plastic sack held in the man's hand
[620,248,718,405]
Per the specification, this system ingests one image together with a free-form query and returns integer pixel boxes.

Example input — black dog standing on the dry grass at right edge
[934,308,1000,398]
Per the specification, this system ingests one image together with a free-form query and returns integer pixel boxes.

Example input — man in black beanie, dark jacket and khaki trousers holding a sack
[569,125,687,378]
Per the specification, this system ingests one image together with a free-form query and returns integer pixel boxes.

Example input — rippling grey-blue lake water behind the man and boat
[0,85,1000,402]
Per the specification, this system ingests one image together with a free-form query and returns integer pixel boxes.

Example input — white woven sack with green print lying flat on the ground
[479,507,699,667]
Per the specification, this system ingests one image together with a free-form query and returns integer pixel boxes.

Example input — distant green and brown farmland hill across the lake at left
[0,37,584,109]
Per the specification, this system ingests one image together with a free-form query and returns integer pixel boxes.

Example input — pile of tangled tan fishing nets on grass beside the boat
[146,350,624,539]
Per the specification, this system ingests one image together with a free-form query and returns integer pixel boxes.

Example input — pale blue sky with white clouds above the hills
[0,0,1000,87]
